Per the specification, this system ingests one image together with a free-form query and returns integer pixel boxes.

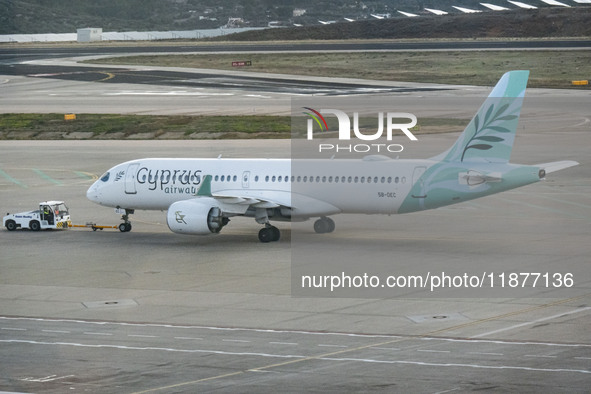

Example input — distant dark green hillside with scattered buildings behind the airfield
[0,0,591,34]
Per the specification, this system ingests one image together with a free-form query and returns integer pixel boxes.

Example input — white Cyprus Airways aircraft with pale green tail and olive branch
[87,71,578,242]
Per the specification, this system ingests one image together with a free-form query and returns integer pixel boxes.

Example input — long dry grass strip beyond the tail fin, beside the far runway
[89,50,591,89]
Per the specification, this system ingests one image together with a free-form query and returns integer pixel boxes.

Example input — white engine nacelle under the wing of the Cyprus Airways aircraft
[166,197,228,235]
